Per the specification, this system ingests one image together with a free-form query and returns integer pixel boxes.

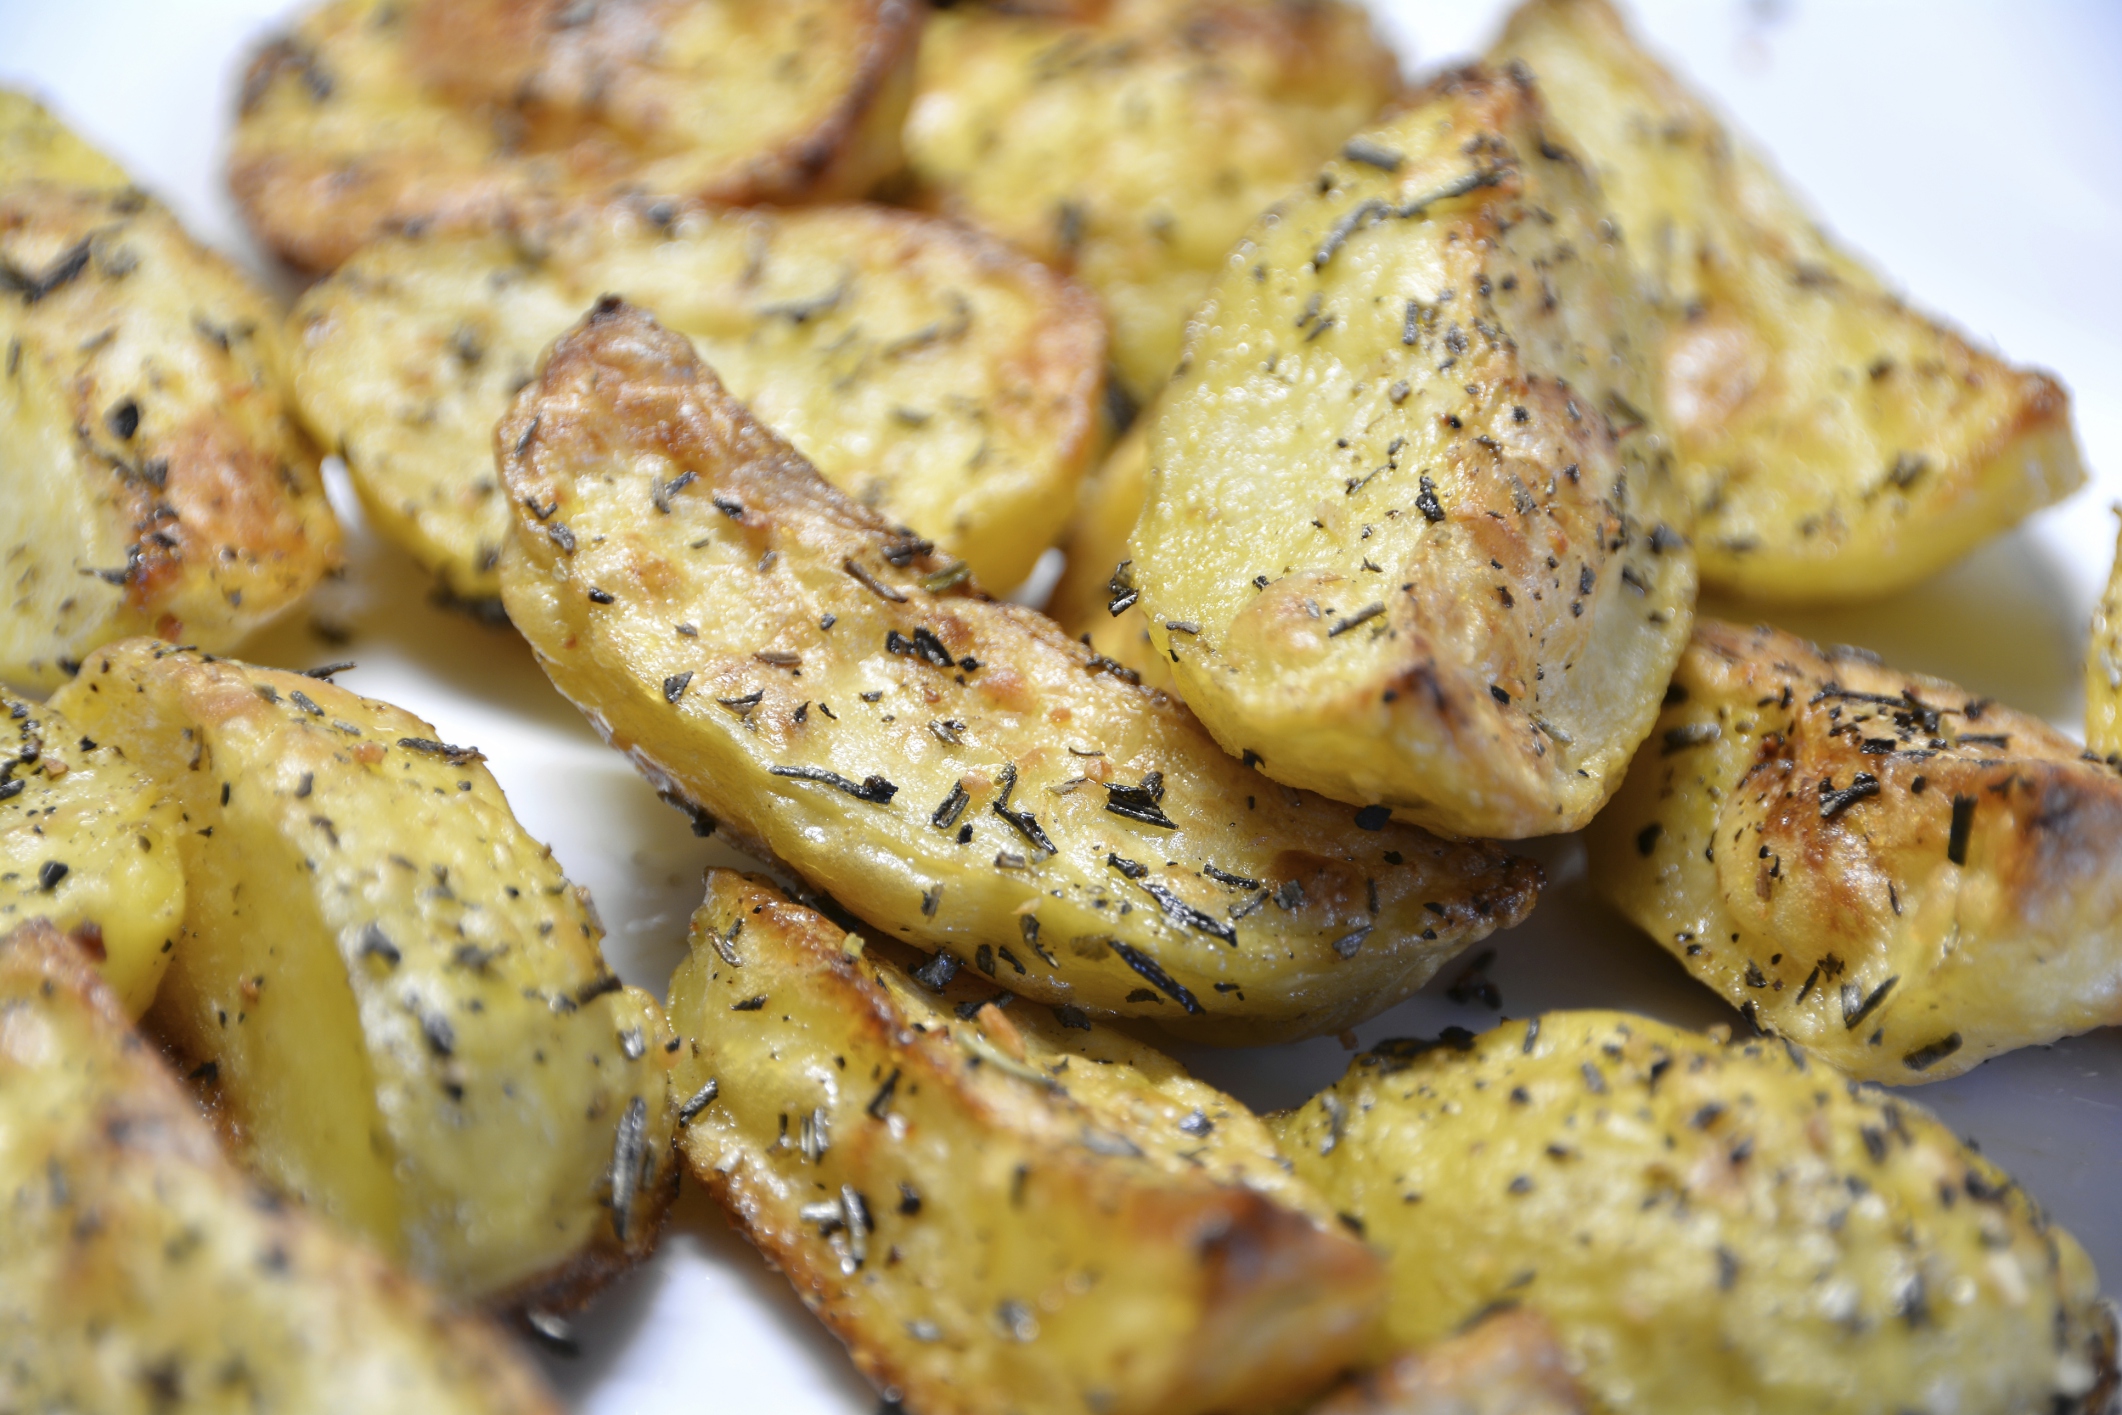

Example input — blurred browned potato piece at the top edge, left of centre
[229,0,925,272]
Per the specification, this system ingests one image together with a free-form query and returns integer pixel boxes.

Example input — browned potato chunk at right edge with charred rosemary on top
[1587,622,2122,1084]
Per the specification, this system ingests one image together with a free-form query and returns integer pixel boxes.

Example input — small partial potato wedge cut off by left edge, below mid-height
[0,692,185,1018]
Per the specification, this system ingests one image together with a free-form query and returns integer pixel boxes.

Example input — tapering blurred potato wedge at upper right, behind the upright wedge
[1494,0,2086,602]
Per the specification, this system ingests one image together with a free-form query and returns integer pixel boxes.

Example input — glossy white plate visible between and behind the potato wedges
[0,0,2122,1415]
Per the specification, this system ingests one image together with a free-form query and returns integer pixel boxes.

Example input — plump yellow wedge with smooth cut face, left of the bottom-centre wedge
[55,641,677,1305]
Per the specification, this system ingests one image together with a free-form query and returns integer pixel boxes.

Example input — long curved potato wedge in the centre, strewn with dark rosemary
[497,301,1538,1042]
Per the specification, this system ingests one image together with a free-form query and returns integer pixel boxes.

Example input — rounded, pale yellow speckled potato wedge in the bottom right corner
[1277,1012,2116,1415]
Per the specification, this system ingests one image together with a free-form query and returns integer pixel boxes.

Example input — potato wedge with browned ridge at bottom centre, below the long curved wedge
[671,870,1381,1415]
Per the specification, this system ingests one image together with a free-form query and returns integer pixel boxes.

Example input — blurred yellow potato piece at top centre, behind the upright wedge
[906,0,1401,401]
